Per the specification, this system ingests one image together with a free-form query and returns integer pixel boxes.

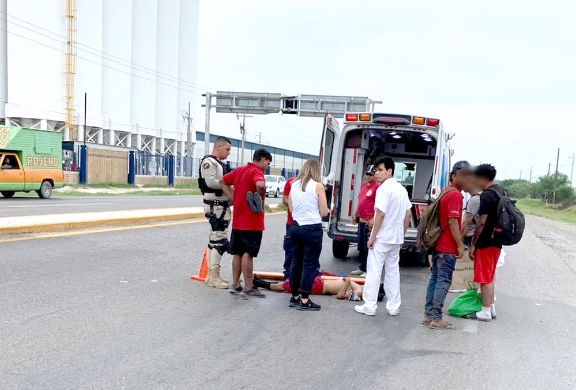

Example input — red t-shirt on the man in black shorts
[223,162,265,231]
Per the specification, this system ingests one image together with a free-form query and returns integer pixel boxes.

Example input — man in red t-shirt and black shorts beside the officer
[220,149,272,299]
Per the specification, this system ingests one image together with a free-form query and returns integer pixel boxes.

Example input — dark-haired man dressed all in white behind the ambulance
[354,157,412,316]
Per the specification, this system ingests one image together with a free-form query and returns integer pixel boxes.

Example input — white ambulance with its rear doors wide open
[320,112,452,263]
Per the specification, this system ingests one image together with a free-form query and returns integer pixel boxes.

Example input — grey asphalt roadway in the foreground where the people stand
[0,216,576,390]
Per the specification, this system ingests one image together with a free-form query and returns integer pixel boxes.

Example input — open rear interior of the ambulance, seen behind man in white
[338,129,437,225]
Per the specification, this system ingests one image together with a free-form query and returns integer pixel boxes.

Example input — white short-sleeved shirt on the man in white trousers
[374,178,412,245]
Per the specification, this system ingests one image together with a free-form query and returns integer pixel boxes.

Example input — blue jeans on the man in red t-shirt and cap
[424,252,456,321]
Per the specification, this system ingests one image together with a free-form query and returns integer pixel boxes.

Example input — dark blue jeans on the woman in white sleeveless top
[290,221,324,299]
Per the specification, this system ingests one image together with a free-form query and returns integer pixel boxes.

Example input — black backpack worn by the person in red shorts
[487,187,526,246]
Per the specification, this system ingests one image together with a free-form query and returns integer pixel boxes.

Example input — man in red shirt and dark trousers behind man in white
[352,165,380,278]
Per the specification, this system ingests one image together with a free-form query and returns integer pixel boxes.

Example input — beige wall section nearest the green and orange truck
[87,149,128,184]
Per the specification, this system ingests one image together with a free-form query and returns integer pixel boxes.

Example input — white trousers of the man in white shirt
[362,243,401,313]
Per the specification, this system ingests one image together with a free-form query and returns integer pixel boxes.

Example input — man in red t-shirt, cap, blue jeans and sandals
[422,161,472,330]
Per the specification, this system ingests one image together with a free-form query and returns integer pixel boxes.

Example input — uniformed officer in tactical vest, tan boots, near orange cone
[198,137,232,289]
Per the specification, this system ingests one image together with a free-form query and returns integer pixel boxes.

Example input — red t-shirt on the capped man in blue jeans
[436,183,462,254]
